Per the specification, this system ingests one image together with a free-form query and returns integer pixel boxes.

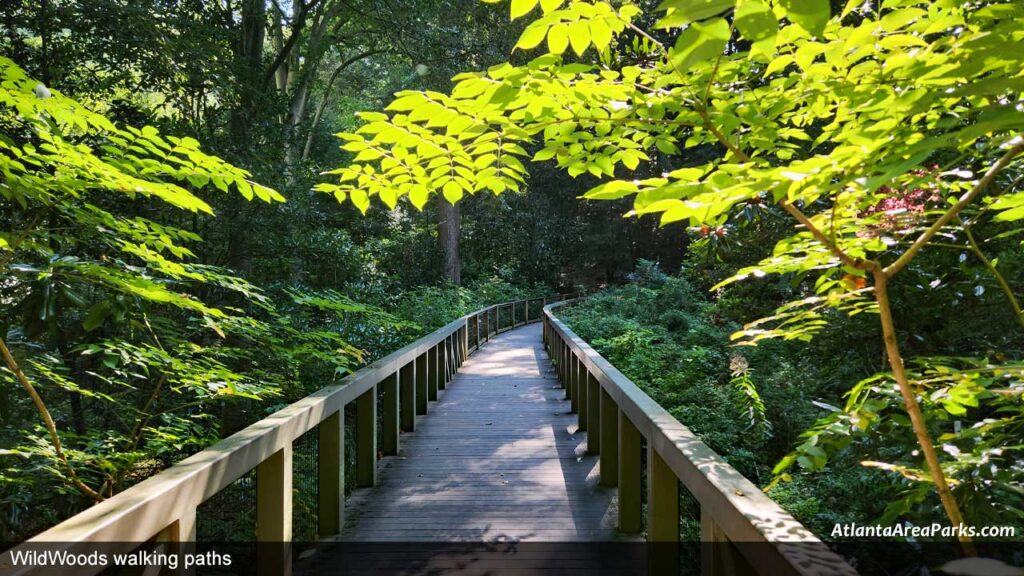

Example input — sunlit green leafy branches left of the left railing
[0,58,372,539]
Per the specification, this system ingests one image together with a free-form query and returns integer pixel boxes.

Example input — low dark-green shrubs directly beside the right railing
[560,270,897,537]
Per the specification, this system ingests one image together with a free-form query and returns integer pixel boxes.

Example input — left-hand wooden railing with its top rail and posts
[0,294,574,576]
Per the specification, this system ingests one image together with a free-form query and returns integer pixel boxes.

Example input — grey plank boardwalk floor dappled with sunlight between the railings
[340,324,618,542]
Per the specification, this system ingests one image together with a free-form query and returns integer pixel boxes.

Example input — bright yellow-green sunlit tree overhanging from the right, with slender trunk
[318,0,1024,541]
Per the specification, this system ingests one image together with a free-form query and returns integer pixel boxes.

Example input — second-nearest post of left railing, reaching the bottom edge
[256,443,292,576]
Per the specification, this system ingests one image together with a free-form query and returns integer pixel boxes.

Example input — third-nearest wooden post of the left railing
[316,409,345,536]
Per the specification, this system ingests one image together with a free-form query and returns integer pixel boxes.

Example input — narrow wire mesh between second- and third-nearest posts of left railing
[292,427,319,551]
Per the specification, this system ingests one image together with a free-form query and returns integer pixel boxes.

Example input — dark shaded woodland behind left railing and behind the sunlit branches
[0,0,687,541]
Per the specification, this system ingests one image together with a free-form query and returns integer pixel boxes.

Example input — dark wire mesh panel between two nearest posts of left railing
[196,463,256,542]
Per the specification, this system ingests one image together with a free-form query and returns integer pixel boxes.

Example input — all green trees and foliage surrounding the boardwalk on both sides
[0,0,1024,565]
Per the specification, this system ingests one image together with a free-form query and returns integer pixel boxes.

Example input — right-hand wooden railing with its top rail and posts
[543,298,856,575]
